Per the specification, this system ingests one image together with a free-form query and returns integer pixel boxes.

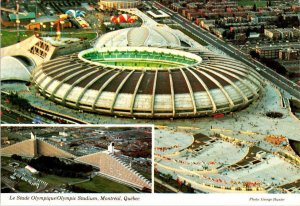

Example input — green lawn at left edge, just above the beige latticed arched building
[1,30,33,47]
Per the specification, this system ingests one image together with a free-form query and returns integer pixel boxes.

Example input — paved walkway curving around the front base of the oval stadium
[2,79,300,140]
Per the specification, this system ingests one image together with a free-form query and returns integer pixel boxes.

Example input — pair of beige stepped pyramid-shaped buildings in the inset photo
[0,133,152,191]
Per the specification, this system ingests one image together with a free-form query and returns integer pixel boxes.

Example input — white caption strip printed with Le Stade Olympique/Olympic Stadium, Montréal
[1,193,300,206]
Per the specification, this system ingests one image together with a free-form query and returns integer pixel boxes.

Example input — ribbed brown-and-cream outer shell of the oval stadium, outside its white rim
[33,47,262,118]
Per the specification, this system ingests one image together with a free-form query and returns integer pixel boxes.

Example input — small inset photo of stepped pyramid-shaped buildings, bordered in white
[1,125,152,193]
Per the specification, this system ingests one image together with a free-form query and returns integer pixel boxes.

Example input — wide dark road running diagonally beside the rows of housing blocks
[151,1,300,99]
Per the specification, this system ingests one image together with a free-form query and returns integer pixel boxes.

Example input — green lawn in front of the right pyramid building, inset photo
[75,176,136,193]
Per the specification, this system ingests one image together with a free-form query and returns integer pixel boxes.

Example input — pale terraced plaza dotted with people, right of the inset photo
[155,128,300,193]
